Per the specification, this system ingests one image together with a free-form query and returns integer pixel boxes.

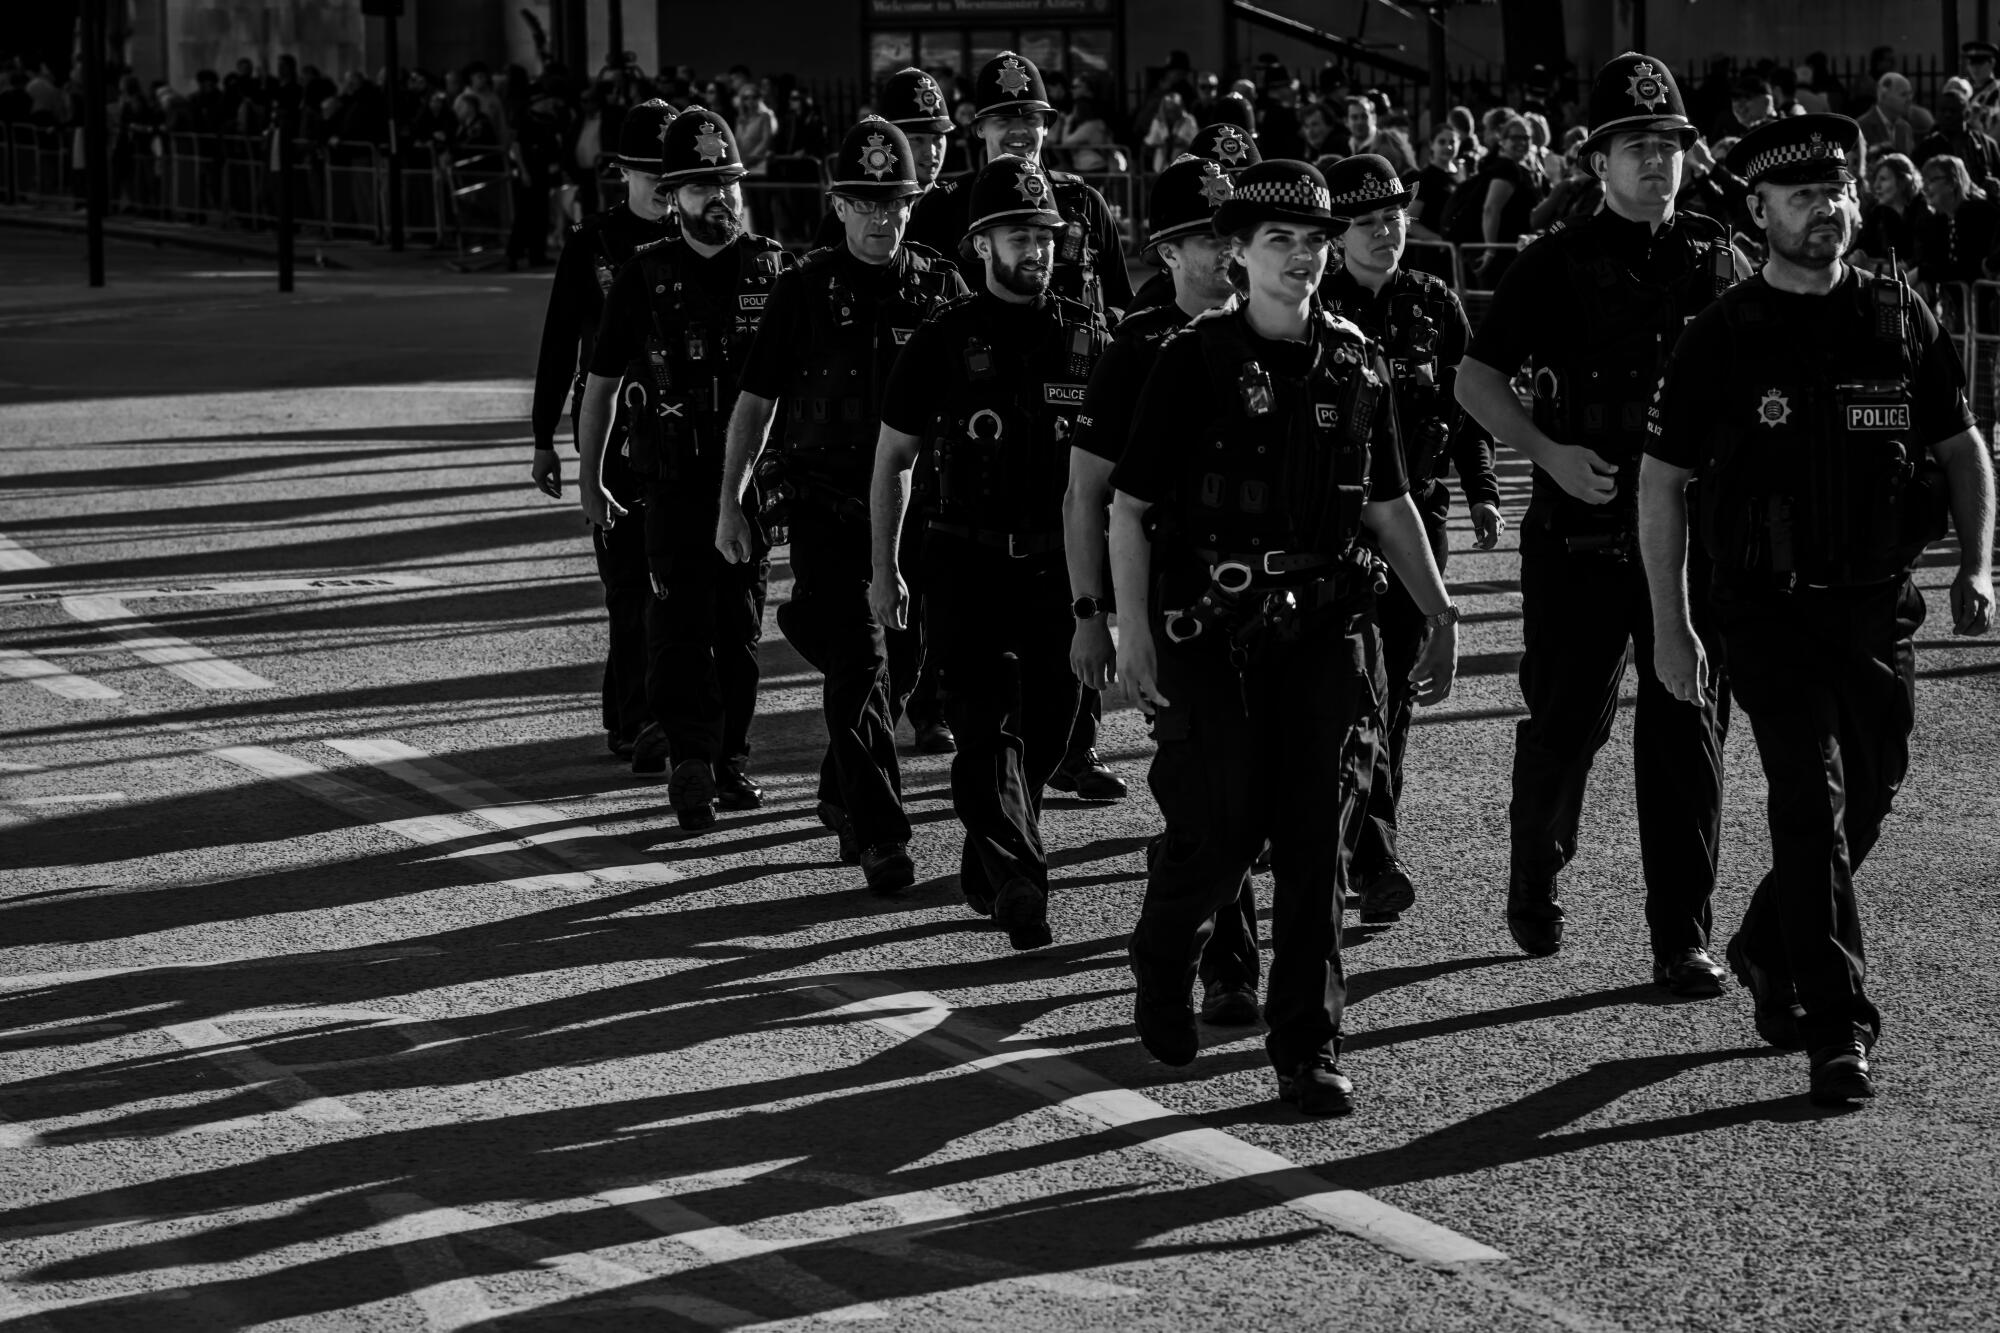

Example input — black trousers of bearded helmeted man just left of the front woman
[924,532,1080,901]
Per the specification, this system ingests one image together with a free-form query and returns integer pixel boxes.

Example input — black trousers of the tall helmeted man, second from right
[1508,514,1728,953]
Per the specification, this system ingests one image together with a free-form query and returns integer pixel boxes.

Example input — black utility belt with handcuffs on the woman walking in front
[1162,546,1388,646]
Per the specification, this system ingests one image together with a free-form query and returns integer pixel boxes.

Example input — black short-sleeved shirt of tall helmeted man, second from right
[1468,208,1708,374]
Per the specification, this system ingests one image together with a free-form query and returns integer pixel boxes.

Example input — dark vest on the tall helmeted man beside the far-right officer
[1528,214,1736,536]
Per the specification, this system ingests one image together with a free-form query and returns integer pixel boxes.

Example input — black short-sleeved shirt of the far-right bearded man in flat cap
[1646,268,1974,474]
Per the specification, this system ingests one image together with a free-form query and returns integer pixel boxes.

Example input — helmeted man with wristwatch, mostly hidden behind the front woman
[1062,156,1260,1027]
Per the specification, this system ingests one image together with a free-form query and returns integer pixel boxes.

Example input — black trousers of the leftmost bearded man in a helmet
[646,482,770,765]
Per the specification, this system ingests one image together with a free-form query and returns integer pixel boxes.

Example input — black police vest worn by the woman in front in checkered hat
[1178,310,1390,562]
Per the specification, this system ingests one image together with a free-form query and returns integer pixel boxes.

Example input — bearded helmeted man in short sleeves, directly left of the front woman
[868,156,1106,949]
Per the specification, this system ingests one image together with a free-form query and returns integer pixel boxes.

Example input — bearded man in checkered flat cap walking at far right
[1640,114,1994,1105]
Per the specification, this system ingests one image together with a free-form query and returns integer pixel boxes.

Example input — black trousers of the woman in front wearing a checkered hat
[1132,614,1382,1071]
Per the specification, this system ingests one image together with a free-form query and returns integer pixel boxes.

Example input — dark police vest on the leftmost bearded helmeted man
[620,236,790,486]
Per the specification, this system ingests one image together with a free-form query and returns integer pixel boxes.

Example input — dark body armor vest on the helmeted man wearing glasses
[784,242,956,496]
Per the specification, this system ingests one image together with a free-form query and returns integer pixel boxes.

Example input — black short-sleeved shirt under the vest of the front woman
[1112,314,1410,504]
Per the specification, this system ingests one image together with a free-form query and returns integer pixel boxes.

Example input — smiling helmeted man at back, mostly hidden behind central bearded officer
[910,50,1132,801]
